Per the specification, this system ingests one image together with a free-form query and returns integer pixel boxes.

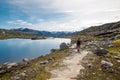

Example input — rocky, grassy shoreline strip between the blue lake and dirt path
[0,43,69,80]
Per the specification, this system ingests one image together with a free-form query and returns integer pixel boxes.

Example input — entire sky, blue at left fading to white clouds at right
[0,0,120,31]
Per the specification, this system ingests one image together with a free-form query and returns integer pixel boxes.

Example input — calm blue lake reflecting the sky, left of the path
[0,38,70,64]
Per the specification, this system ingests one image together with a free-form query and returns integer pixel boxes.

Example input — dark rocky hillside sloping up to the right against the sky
[74,21,120,38]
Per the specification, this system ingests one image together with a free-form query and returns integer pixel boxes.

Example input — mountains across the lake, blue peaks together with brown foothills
[0,28,74,39]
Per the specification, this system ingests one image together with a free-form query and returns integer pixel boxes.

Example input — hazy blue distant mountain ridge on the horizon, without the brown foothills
[0,28,75,37]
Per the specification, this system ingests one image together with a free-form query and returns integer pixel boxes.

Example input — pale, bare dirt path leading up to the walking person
[48,49,88,80]
